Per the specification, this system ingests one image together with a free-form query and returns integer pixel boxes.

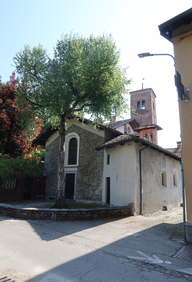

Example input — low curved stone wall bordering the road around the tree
[0,204,131,220]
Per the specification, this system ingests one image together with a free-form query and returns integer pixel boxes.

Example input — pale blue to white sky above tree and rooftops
[0,0,192,148]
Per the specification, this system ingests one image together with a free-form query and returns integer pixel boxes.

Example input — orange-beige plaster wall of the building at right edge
[173,22,192,224]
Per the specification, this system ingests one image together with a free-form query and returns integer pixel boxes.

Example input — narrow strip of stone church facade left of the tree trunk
[45,137,59,196]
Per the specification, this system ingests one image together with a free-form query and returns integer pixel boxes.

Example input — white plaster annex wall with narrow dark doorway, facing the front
[102,142,136,206]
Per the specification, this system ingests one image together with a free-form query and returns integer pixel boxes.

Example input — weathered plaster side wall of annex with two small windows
[135,143,182,213]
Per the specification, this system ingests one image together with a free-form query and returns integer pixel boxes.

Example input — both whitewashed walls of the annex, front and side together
[102,142,182,214]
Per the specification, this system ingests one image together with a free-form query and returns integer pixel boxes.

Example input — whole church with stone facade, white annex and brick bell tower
[34,88,181,214]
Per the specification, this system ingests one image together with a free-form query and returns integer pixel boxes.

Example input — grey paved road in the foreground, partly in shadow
[0,212,192,282]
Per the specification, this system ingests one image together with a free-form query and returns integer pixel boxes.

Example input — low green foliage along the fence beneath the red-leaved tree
[0,154,44,178]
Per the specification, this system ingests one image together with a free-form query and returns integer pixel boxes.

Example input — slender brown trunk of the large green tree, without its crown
[55,115,67,209]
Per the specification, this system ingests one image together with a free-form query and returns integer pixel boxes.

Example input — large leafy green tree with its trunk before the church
[14,34,130,208]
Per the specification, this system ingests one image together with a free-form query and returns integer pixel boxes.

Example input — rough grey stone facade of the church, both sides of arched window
[45,124,104,201]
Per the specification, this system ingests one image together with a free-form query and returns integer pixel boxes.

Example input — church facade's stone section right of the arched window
[67,125,104,201]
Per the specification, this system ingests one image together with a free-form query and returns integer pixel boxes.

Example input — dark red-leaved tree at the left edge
[0,73,40,158]
